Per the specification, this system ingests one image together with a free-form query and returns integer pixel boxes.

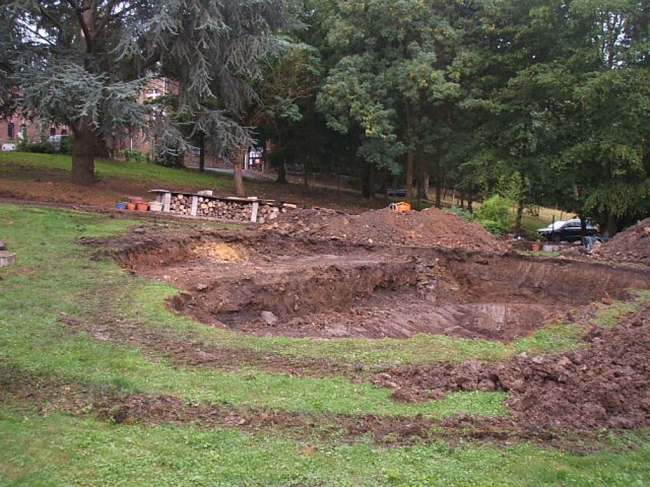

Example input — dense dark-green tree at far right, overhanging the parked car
[466,0,650,234]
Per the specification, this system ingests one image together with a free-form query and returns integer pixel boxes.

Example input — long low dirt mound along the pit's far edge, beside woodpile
[265,208,504,251]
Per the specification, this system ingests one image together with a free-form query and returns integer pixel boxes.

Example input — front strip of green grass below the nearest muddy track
[0,410,650,487]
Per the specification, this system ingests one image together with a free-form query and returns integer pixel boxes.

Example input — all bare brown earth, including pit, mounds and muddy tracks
[0,176,650,450]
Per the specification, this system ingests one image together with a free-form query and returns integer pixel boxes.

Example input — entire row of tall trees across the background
[0,0,650,234]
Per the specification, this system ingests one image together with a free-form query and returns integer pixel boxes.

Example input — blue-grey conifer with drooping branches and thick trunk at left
[3,0,288,185]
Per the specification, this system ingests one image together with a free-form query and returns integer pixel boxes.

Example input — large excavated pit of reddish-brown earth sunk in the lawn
[118,231,648,342]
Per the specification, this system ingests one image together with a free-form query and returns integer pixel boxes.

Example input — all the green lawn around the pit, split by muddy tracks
[0,204,650,487]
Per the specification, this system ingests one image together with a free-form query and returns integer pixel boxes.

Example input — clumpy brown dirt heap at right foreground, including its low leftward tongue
[374,305,650,429]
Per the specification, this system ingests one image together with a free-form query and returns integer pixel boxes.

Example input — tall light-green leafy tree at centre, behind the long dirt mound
[319,0,458,200]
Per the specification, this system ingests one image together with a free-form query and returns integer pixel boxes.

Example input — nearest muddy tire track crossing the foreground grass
[0,361,610,454]
